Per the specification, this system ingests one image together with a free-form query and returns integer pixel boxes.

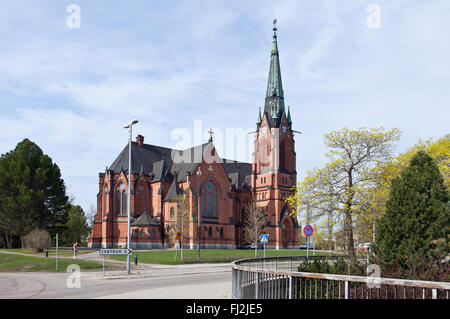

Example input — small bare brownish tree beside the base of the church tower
[244,200,266,257]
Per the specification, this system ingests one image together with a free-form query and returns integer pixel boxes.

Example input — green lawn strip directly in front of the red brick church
[110,249,329,265]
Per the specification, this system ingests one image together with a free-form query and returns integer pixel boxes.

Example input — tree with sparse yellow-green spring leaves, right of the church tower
[286,127,400,261]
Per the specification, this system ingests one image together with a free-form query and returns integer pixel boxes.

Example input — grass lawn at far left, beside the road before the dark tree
[0,253,117,272]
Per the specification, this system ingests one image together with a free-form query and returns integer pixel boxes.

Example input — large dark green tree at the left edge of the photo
[0,139,69,247]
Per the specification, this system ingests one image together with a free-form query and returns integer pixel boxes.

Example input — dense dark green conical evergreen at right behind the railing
[375,151,450,273]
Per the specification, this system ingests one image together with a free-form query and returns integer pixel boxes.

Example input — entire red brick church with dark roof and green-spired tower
[89,28,300,249]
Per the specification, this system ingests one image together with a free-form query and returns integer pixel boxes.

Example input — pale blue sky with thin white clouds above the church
[0,0,450,215]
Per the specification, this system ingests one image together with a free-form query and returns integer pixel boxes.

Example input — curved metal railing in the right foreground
[232,256,450,299]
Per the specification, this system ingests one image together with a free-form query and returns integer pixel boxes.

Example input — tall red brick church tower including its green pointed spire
[252,20,299,249]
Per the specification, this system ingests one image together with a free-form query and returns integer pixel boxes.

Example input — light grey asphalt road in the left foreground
[0,266,231,299]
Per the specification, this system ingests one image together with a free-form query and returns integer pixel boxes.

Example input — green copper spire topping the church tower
[264,19,285,125]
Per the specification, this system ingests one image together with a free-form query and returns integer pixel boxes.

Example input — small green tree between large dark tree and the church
[63,205,89,246]
